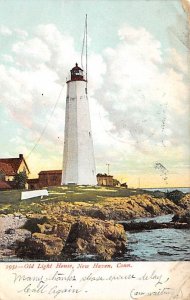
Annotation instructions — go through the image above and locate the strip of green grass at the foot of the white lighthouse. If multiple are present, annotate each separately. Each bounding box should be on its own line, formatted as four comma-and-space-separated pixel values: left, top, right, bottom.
0, 186, 140, 214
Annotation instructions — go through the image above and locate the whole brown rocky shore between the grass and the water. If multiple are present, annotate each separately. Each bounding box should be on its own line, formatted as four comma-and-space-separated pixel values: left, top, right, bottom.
0, 193, 190, 260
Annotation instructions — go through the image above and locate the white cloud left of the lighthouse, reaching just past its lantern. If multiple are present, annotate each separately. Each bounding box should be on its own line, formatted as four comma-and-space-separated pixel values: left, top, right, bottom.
0, 24, 104, 166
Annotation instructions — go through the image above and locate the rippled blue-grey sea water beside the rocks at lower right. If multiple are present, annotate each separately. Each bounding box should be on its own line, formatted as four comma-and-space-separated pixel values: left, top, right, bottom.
123, 215, 190, 261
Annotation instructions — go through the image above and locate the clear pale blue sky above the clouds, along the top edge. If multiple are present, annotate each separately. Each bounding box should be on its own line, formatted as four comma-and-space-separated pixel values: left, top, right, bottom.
0, 0, 184, 55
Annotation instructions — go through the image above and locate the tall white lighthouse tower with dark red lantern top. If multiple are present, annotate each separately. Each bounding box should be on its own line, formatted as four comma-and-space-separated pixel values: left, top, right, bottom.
62, 63, 97, 185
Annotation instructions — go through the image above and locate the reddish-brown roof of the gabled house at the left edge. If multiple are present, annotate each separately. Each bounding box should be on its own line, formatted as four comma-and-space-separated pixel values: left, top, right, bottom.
0, 154, 30, 176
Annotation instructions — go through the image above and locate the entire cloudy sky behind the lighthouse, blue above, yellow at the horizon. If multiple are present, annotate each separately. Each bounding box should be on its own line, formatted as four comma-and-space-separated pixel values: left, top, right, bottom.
0, 0, 190, 187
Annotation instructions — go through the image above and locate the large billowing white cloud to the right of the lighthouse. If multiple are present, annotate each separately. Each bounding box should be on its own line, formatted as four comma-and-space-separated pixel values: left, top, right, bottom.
95, 26, 189, 155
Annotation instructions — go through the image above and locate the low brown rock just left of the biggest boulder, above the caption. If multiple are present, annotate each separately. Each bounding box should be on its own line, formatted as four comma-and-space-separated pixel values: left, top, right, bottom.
16, 233, 63, 259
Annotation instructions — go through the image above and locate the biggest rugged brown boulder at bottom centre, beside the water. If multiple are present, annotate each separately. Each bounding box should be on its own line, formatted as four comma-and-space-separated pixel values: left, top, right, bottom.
63, 218, 126, 260
